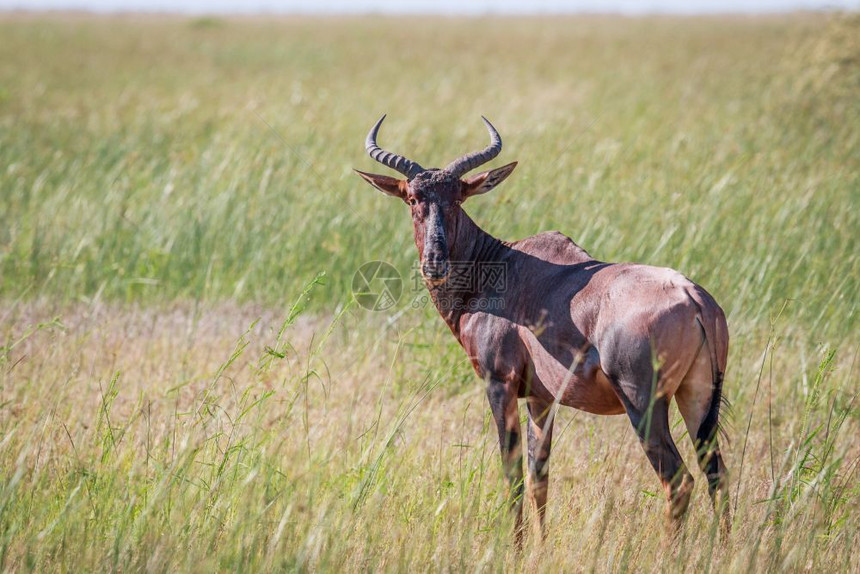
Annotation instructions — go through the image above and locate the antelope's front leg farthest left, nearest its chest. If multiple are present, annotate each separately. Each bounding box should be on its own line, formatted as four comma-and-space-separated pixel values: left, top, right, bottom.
487, 381, 523, 546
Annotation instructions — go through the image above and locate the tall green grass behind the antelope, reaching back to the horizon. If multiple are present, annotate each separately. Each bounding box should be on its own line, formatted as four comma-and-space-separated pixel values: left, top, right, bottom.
0, 16, 860, 342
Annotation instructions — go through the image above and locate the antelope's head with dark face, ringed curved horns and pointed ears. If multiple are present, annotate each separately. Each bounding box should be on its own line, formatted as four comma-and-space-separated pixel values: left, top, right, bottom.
355, 116, 517, 285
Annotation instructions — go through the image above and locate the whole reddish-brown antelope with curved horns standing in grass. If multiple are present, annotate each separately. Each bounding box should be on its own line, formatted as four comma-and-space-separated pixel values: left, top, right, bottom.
355, 115, 730, 544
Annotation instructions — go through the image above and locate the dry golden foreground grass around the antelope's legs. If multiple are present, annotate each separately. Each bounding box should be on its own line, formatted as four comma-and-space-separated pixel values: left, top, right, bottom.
0, 294, 860, 572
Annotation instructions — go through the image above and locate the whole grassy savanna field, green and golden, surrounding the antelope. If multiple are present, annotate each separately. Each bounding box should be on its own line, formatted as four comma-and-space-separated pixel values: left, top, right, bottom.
0, 14, 860, 572
